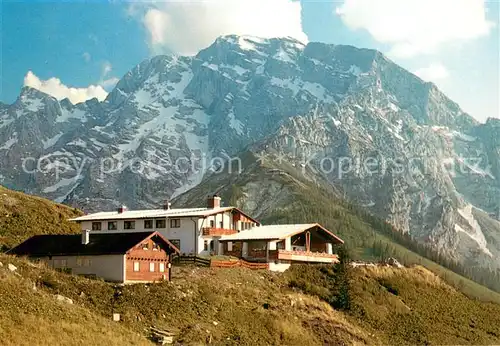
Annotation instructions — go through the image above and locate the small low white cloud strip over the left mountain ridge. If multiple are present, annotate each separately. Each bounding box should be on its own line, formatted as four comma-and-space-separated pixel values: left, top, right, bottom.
24, 71, 108, 104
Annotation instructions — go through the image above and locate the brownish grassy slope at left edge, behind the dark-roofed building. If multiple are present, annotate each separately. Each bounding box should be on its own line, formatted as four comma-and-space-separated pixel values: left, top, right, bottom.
0, 186, 81, 249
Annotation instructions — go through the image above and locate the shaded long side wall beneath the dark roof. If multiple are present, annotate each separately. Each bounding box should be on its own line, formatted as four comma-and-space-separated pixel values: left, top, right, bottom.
40, 255, 125, 282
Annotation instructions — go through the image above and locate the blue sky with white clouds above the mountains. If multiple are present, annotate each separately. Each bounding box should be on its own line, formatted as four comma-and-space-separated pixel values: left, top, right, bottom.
0, 0, 500, 121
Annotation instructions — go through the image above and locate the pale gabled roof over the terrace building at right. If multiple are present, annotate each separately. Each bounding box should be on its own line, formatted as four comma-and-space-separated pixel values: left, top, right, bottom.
219, 223, 344, 244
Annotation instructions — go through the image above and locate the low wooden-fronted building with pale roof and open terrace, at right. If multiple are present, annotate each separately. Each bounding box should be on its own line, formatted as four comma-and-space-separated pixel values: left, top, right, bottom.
219, 223, 344, 271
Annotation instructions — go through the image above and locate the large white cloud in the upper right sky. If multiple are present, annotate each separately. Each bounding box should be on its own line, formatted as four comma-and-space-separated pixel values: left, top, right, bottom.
336, 0, 494, 58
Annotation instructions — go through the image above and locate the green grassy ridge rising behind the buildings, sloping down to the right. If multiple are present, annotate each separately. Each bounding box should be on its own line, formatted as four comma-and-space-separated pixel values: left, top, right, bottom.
174, 153, 500, 303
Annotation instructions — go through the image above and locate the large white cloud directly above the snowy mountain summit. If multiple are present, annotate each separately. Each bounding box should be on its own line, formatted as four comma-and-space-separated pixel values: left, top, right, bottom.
136, 0, 307, 54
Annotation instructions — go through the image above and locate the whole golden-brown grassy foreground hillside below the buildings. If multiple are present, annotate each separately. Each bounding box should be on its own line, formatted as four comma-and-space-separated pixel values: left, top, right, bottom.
0, 255, 500, 345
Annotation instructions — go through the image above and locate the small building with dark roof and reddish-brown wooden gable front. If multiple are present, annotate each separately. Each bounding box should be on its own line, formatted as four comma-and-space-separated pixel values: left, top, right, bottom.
8, 230, 179, 283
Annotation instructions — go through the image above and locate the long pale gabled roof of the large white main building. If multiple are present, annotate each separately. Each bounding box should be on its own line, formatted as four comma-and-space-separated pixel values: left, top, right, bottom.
70, 207, 260, 224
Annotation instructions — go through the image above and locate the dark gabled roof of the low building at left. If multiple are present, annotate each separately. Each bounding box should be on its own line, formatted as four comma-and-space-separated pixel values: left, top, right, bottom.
8, 232, 179, 257
